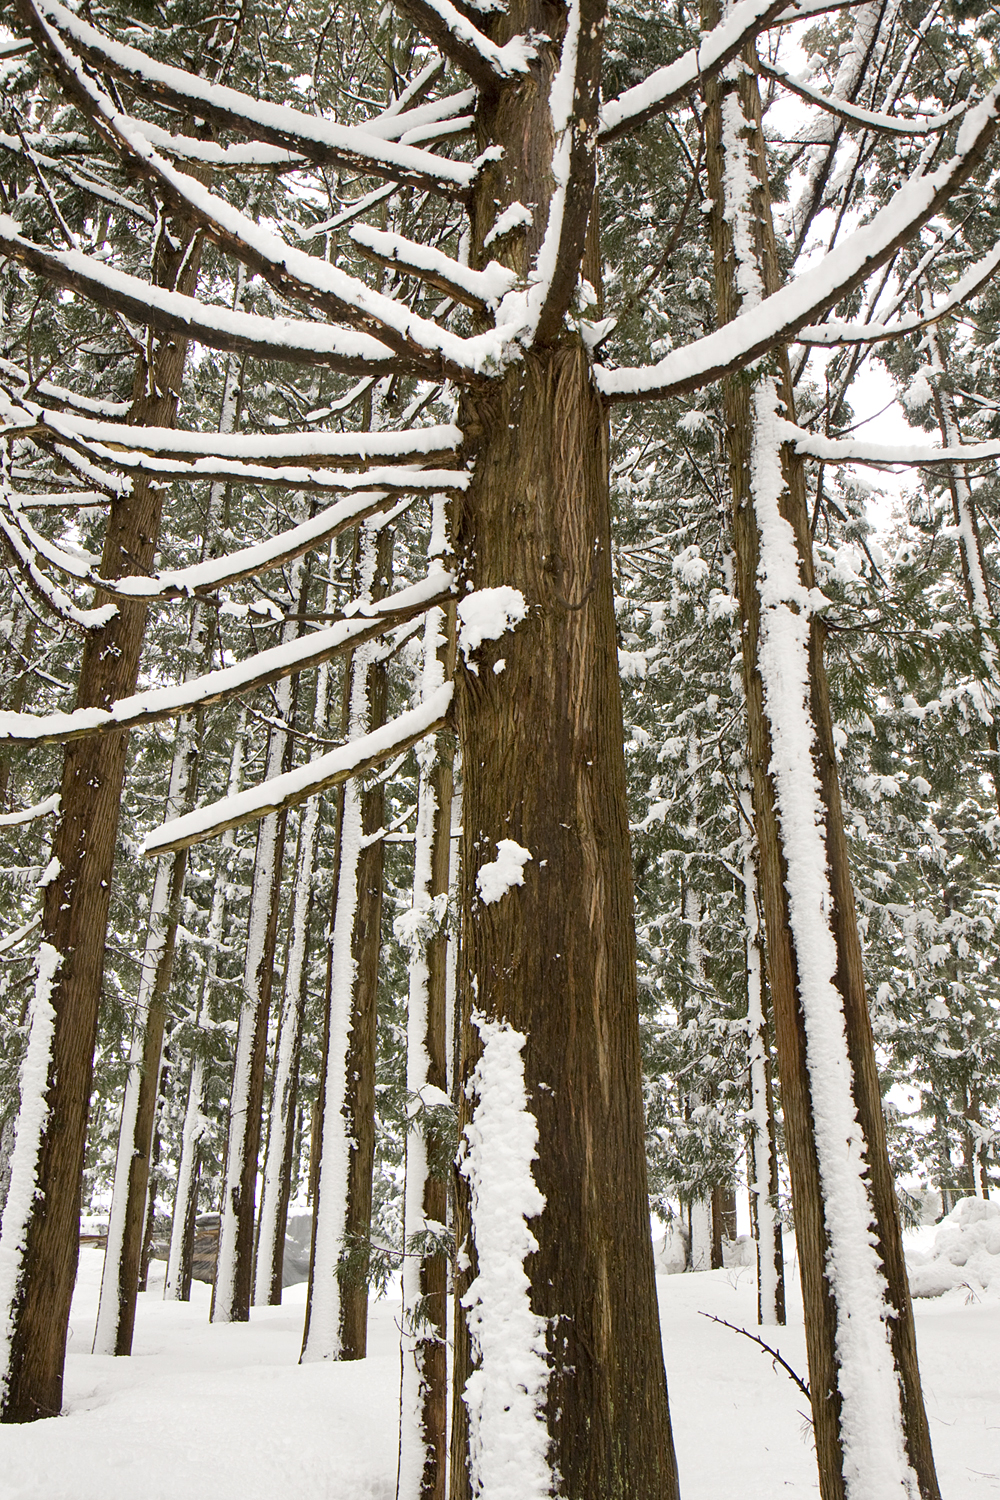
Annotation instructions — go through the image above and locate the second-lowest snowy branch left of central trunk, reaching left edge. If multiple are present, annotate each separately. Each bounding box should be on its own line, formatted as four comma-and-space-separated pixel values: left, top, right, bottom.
0, 573, 454, 744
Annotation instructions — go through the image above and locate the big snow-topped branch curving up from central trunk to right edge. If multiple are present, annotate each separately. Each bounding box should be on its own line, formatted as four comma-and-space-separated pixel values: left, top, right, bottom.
594, 89, 1000, 401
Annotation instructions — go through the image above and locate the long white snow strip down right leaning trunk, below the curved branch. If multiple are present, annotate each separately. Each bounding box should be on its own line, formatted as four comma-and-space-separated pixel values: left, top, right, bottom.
751, 378, 918, 1500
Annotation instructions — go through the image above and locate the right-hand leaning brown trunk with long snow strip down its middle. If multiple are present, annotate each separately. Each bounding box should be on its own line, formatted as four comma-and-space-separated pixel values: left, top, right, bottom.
706, 8, 939, 1500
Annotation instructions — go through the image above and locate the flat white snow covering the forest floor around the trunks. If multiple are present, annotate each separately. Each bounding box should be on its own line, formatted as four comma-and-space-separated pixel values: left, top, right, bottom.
0, 1250, 1000, 1500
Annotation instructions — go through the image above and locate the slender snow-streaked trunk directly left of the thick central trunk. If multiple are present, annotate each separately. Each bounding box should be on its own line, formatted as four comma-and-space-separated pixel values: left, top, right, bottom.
396, 498, 454, 1500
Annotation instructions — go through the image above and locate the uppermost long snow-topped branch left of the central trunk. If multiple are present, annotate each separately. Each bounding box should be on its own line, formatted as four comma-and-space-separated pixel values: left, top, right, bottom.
16, 0, 478, 197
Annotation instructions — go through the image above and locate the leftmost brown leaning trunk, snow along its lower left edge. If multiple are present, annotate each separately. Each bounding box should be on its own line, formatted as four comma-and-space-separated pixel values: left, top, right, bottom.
0, 222, 199, 1422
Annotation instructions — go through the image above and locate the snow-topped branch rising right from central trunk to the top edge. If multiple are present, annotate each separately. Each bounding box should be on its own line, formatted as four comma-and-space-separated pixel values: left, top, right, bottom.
600, 0, 791, 143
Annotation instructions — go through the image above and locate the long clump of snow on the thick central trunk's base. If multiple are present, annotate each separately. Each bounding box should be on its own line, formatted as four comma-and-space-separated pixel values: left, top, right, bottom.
460, 1020, 552, 1500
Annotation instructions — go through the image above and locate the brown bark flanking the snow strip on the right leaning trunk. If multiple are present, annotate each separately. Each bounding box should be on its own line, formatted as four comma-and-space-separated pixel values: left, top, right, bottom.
706, 23, 939, 1500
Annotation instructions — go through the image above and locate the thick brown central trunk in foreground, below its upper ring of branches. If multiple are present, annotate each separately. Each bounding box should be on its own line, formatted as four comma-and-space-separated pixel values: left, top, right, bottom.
451, 337, 676, 1500
